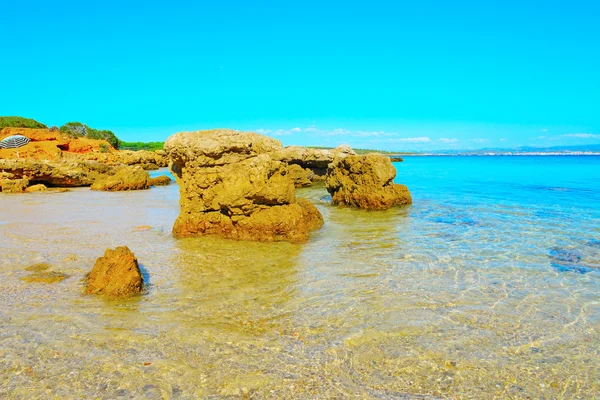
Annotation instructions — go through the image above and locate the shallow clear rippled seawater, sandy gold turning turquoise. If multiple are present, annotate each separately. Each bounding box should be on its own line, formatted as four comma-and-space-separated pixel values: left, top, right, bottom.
0, 157, 600, 399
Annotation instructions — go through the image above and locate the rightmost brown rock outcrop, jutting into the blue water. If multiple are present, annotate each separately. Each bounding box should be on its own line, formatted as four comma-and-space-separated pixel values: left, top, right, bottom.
325, 154, 412, 210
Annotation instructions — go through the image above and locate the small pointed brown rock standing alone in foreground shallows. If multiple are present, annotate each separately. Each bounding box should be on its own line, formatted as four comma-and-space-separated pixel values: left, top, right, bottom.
87, 246, 144, 297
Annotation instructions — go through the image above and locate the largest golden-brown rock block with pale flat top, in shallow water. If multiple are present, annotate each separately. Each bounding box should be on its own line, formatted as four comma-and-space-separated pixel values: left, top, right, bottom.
165, 129, 323, 242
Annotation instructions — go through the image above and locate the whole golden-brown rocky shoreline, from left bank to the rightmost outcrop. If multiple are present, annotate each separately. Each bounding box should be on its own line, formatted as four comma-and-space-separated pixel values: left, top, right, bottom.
0, 128, 412, 255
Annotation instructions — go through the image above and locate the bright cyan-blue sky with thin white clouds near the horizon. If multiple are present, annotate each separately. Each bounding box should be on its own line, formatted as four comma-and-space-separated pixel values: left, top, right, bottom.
0, 0, 600, 150
